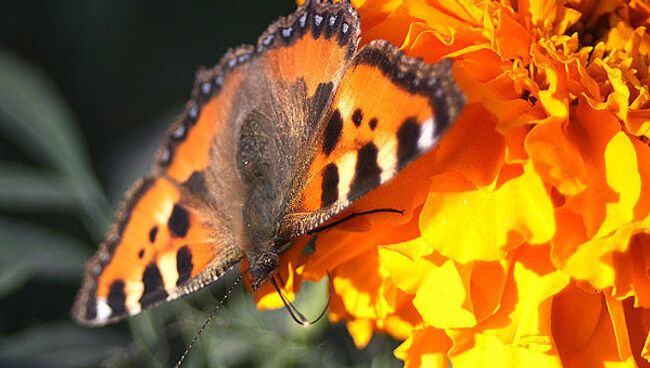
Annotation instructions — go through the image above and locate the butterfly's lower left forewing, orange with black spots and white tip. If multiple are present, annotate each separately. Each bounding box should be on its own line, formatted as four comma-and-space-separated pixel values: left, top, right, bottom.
73, 177, 242, 325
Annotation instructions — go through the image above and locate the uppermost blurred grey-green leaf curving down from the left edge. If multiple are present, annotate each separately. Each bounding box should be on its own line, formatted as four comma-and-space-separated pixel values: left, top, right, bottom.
0, 50, 110, 235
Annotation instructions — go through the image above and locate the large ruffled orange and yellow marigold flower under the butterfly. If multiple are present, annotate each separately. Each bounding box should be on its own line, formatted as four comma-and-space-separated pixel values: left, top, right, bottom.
257, 0, 650, 367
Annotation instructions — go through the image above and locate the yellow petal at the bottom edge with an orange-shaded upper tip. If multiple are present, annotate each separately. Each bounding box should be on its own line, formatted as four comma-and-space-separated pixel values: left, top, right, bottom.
447, 246, 569, 367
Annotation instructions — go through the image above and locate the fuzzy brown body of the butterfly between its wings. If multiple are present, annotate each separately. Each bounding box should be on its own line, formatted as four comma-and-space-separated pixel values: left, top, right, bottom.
237, 105, 306, 289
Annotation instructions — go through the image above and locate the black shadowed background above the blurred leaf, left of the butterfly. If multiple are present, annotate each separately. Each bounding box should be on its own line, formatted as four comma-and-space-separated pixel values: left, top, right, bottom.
0, 0, 295, 181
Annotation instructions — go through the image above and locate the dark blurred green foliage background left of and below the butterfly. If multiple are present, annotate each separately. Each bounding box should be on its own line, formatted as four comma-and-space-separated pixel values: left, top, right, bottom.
0, 0, 399, 367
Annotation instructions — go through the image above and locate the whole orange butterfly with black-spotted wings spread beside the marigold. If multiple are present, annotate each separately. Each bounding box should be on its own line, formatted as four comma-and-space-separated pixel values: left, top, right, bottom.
72, 0, 465, 326
